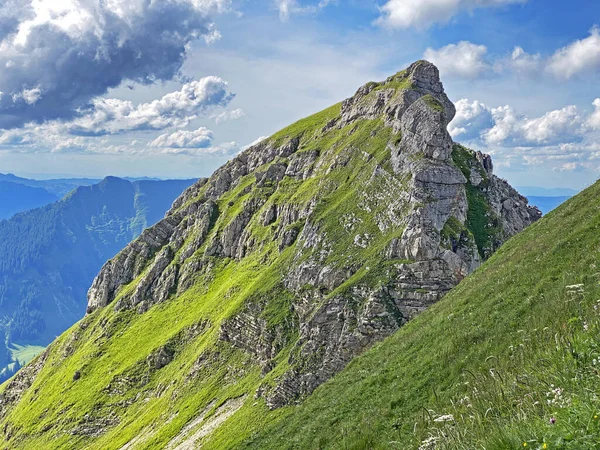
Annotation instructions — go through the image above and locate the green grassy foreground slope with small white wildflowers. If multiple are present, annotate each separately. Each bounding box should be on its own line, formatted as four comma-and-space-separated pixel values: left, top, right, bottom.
241, 178, 600, 450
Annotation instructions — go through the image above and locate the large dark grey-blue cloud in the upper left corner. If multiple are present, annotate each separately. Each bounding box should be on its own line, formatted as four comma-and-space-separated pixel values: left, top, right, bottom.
0, 0, 230, 129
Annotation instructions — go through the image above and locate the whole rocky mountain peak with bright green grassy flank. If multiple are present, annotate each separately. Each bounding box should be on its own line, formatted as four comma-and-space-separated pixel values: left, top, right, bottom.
0, 61, 540, 449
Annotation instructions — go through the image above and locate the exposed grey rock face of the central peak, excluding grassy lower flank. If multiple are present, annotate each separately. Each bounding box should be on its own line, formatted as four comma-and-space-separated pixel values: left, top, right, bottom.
83, 61, 541, 408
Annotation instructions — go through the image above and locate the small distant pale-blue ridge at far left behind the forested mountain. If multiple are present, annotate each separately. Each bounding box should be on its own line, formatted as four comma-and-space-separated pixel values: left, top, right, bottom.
0, 181, 58, 219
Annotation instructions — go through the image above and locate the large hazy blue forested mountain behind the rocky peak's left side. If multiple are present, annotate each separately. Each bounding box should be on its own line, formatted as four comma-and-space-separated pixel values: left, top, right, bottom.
0, 177, 192, 382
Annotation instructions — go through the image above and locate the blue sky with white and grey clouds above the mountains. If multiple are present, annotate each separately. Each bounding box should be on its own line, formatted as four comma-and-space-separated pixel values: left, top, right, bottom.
0, 0, 600, 189
